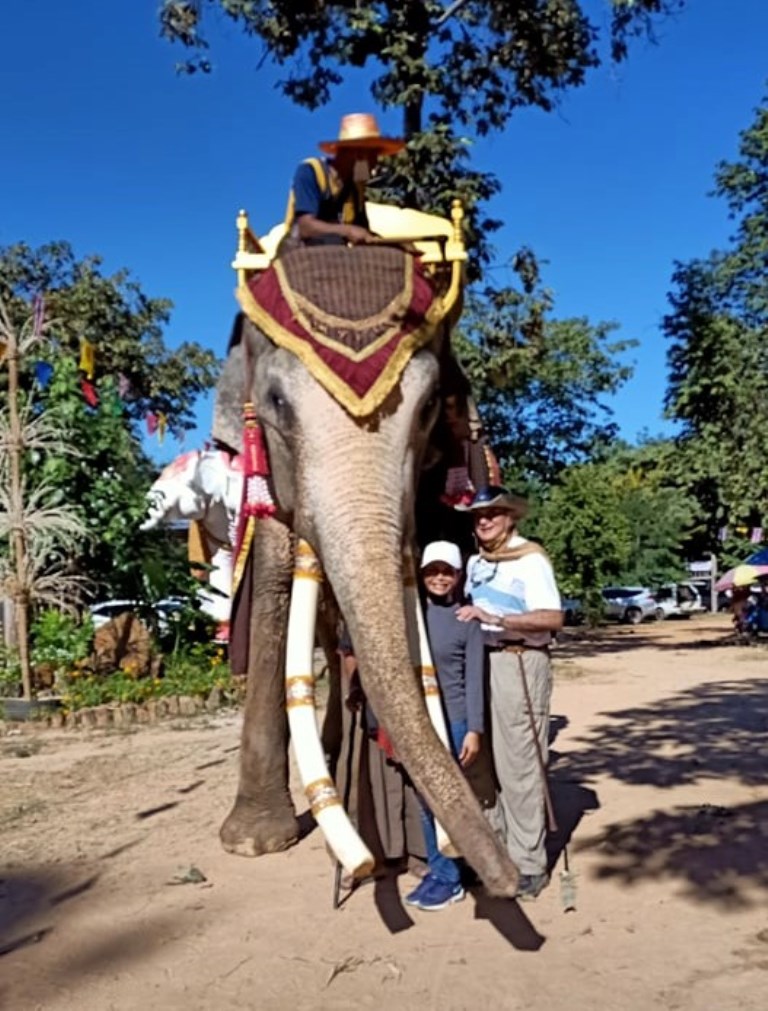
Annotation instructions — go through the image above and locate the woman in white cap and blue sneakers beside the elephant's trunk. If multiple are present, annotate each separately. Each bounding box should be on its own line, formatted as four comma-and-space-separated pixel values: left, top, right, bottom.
405, 541, 483, 911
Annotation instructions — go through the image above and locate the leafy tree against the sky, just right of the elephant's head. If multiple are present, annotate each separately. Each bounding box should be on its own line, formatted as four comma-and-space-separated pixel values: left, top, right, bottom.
454, 250, 637, 489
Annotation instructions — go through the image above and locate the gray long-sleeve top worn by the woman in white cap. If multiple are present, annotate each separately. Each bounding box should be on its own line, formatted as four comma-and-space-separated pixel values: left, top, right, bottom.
426, 598, 484, 734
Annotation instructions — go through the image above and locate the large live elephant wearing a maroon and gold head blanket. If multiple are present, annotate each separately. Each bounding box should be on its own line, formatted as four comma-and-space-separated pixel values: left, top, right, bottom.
213, 238, 517, 897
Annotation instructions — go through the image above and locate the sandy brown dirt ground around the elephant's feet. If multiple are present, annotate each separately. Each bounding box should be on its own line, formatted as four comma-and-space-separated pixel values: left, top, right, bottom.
0, 617, 768, 1011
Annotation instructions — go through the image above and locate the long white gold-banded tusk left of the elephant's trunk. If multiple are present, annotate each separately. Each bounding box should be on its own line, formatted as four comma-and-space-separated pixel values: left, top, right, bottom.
285, 540, 375, 878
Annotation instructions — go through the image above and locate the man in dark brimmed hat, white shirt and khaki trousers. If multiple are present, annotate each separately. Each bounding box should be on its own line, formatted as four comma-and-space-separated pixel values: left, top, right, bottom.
457, 485, 563, 899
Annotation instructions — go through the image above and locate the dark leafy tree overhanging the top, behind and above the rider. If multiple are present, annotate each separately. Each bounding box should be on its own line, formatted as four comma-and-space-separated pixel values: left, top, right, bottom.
160, 0, 684, 270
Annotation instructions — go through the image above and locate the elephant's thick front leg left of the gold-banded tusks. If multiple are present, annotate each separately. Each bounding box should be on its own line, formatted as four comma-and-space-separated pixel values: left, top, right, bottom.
220, 520, 298, 856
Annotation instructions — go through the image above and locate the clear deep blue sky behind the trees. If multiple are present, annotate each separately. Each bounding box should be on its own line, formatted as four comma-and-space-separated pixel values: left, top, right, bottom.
0, 0, 768, 458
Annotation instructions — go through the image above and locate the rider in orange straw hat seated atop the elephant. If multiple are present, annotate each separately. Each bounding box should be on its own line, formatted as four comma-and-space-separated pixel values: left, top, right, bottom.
280, 112, 405, 252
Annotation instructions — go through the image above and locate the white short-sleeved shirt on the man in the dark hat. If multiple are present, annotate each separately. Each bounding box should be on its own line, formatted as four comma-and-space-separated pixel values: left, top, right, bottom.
464, 534, 561, 646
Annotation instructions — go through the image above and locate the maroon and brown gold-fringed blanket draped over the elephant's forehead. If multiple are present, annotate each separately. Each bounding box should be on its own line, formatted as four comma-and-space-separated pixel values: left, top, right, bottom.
237, 246, 442, 418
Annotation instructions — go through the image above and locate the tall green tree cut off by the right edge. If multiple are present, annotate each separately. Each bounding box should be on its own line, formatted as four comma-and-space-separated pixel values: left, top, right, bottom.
664, 92, 768, 551
